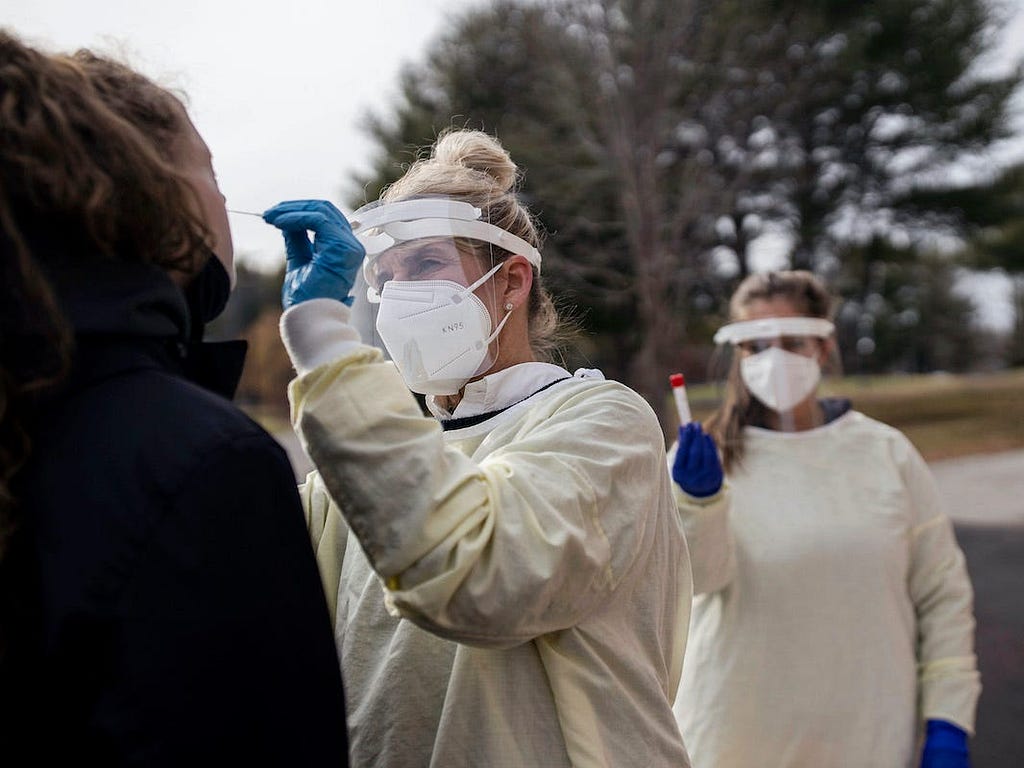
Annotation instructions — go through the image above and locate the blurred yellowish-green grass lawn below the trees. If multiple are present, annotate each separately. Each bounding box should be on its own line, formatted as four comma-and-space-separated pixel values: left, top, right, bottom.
687, 369, 1024, 461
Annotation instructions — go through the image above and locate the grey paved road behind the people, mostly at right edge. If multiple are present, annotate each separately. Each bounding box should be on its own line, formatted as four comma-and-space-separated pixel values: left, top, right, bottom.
279, 433, 1024, 768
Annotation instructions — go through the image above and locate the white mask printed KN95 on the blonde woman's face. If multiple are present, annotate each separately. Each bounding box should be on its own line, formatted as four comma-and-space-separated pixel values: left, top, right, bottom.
377, 263, 511, 395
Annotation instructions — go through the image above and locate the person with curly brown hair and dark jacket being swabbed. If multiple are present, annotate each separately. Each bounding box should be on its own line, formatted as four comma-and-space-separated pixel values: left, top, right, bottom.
0, 30, 347, 768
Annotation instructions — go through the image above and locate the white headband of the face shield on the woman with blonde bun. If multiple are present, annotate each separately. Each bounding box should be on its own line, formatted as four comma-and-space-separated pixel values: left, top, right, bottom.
351, 198, 541, 302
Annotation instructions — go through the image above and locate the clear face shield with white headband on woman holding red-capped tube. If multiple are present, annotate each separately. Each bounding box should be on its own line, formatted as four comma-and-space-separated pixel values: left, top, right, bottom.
715, 317, 836, 429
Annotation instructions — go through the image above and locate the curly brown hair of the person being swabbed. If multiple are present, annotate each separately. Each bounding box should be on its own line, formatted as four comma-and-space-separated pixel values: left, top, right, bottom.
0, 30, 210, 557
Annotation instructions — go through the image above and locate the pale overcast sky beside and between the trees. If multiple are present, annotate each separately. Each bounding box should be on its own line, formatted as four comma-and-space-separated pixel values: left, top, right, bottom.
0, 0, 1024, 323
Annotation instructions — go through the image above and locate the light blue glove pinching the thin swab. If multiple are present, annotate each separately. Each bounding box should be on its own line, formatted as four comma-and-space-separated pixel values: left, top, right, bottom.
263, 200, 366, 309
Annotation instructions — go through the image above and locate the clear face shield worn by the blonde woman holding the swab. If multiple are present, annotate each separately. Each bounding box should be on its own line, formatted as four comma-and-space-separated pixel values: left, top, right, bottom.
352, 197, 541, 395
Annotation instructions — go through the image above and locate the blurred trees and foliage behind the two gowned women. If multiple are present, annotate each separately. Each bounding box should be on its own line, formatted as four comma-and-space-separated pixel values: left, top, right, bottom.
214, 0, 1024, 434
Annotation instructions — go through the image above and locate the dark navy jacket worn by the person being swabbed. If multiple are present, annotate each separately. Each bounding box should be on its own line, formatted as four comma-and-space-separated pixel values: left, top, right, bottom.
0, 264, 347, 766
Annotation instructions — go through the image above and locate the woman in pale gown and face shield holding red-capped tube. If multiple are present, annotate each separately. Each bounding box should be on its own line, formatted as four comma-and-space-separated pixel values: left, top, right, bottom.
670, 271, 980, 768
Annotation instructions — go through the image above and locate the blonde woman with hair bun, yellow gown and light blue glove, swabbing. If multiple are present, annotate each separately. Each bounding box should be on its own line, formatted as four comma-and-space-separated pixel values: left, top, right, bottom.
264, 131, 691, 766
